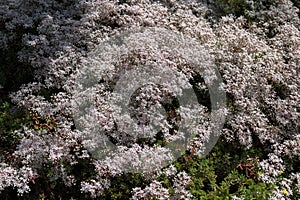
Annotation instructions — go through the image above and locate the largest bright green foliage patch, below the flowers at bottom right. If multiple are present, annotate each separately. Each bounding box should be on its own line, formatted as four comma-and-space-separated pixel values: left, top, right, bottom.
159, 139, 274, 200
